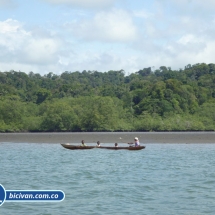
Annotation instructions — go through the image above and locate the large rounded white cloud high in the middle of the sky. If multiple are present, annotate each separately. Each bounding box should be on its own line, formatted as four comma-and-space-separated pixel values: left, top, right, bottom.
66, 9, 137, 42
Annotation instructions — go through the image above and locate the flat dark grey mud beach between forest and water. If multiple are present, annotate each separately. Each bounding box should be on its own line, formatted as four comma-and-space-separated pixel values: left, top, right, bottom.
0, 132, 215, 143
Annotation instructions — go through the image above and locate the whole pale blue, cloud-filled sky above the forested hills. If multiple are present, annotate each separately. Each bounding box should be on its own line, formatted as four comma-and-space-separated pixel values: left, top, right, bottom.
0, 0, 215, 75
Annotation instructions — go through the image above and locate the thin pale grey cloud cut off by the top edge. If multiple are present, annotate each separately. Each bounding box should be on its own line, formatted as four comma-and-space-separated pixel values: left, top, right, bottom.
43, 0, 116, 8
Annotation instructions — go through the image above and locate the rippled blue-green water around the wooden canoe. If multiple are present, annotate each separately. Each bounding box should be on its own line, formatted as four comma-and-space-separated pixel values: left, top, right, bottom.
0, 143, 215, 215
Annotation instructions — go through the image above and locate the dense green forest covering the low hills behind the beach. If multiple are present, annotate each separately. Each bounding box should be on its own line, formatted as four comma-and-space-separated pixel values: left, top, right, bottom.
0, 63, 215, 132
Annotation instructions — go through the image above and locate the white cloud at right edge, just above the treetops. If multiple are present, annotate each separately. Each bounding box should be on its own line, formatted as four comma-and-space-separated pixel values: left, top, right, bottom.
138, 31, 215, 69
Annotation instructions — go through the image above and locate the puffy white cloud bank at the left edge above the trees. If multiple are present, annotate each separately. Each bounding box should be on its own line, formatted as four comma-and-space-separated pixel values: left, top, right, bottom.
0, 19, 61, 66
